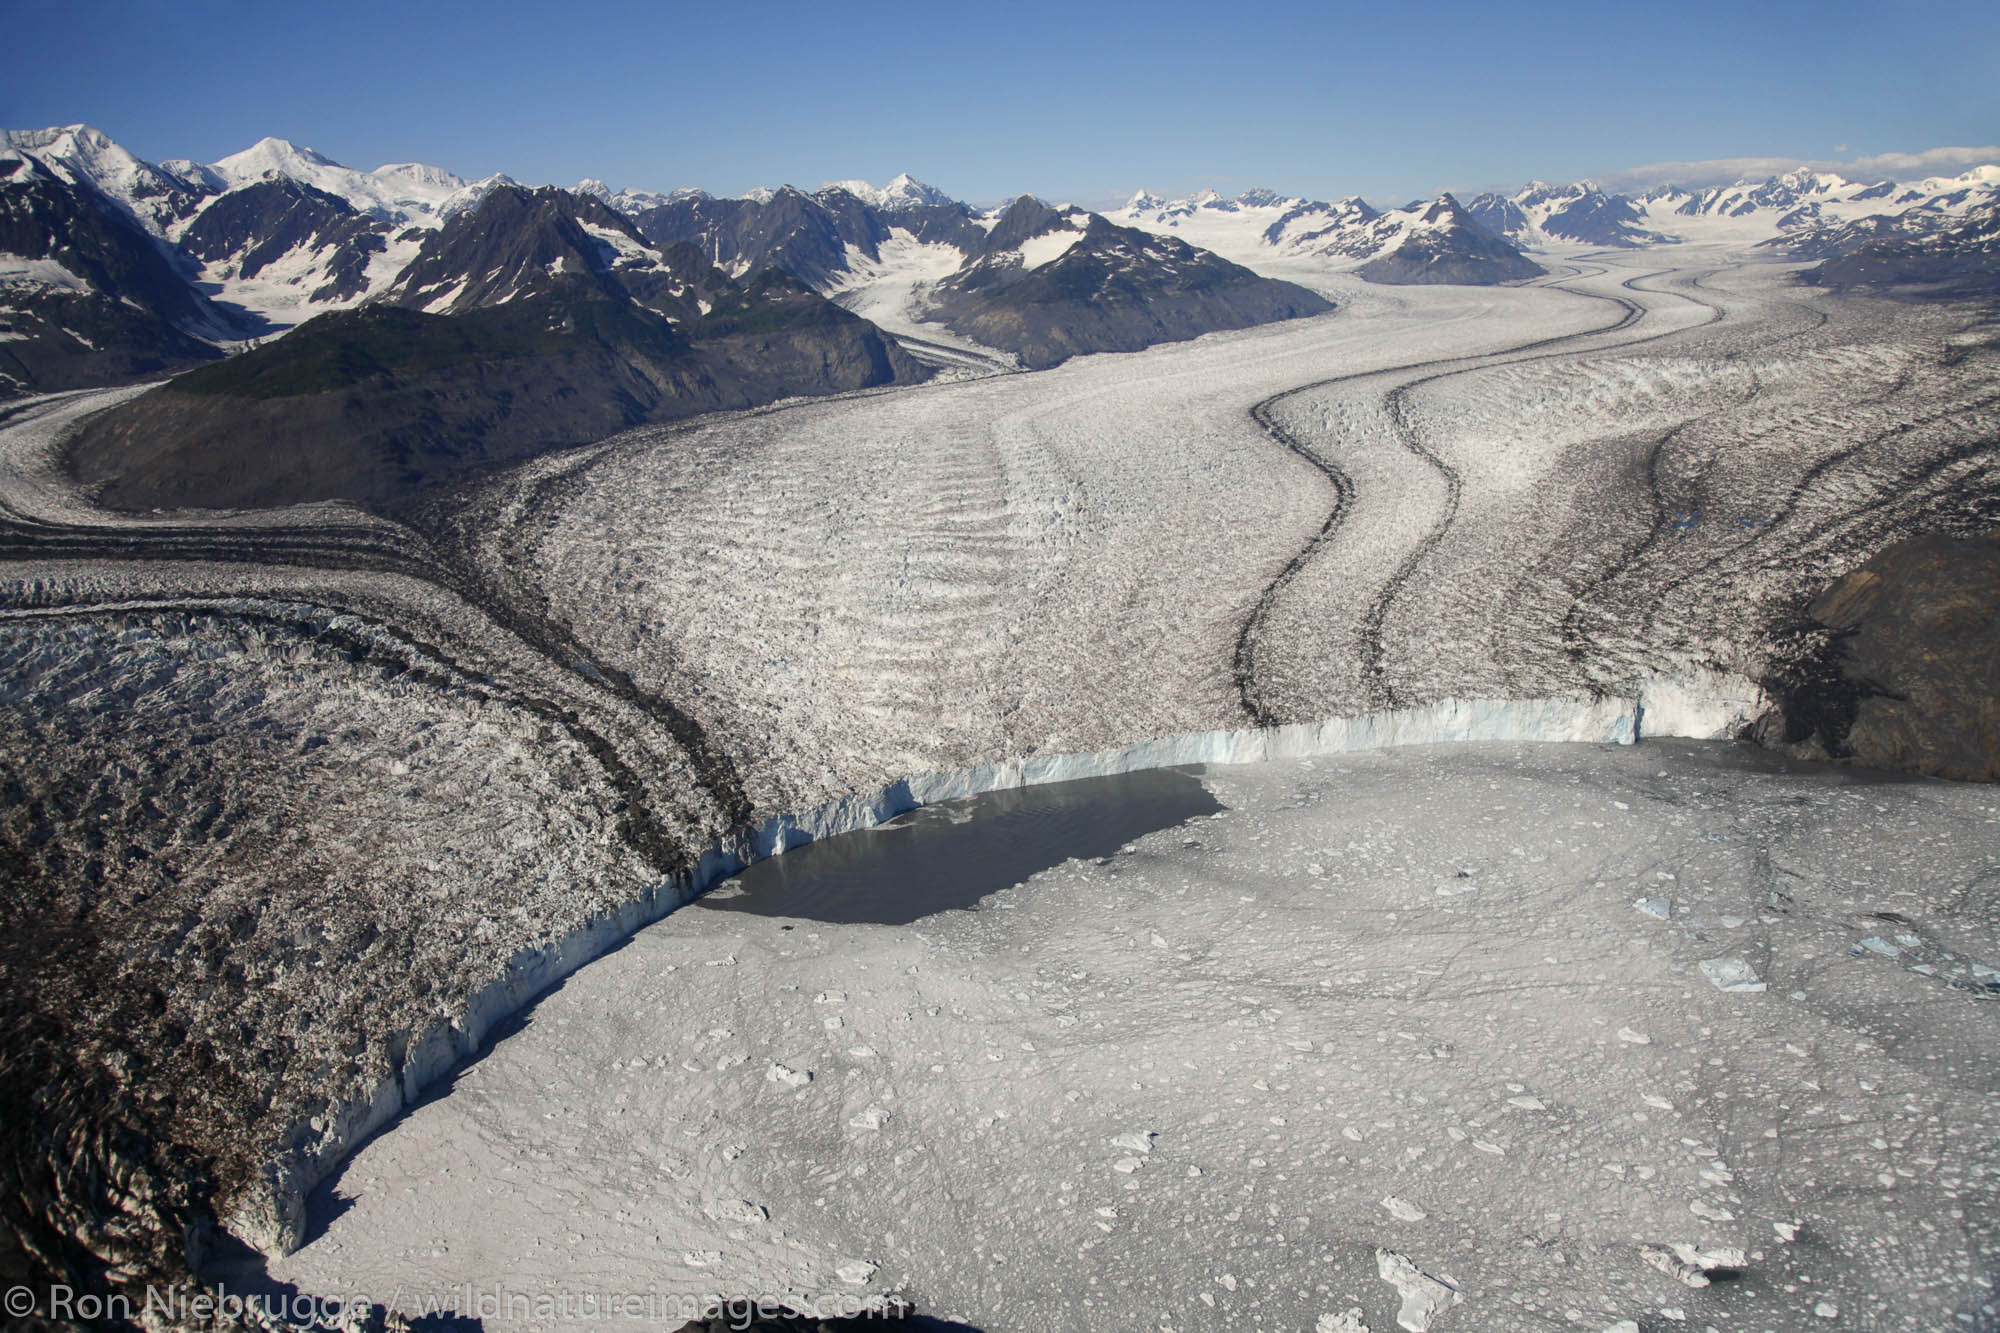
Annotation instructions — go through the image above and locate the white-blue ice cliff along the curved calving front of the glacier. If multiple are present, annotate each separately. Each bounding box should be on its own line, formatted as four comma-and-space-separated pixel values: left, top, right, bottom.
222, 673, 1762, 1257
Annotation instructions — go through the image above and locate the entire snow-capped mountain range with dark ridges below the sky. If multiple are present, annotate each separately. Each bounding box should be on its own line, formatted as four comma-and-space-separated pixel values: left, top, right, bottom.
0, 126, 2000, 504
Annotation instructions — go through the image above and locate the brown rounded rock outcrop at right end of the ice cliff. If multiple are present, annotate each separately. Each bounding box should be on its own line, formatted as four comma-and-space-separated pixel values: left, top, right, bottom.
1754, 532, 2000, 783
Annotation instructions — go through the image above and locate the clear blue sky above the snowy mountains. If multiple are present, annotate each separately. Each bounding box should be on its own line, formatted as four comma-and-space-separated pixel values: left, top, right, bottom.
0, 0, 2000, 202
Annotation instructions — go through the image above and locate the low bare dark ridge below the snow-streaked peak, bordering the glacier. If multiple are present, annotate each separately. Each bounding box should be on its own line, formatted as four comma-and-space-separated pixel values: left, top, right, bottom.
70, 276, 924, 508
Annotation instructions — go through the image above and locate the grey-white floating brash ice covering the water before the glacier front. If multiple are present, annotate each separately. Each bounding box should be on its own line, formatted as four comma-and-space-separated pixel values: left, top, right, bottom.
274, 743, 2000, 1333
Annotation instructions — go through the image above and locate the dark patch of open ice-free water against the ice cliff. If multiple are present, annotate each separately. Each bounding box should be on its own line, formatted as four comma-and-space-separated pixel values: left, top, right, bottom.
700, 765, 1222, 925
